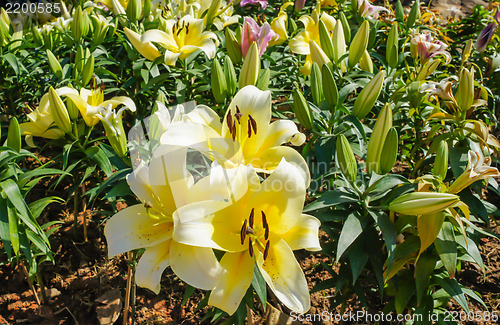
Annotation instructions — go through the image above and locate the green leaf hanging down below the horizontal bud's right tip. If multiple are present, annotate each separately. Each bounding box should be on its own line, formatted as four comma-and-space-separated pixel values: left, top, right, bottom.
434, 222, 457, 278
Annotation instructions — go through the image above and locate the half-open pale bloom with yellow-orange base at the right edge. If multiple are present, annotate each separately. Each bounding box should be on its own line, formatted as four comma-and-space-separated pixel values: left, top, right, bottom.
448, 150, 500, 193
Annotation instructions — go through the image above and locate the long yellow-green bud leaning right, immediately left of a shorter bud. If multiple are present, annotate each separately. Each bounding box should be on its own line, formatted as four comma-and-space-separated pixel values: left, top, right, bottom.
366, 104, 392, 174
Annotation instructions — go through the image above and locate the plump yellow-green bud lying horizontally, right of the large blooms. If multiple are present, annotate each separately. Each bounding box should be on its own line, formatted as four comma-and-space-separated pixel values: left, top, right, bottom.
389, 192, 460, 215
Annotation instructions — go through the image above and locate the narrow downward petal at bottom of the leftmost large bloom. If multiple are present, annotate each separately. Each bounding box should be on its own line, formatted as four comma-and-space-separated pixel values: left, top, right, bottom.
135, 239, 173, 294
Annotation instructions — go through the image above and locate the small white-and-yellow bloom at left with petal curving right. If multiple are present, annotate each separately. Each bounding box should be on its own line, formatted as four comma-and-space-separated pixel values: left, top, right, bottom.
63, 84, 136, 126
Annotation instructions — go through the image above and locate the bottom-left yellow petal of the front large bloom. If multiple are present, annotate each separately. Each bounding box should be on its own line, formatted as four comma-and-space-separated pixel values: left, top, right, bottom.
208, 251, 255, 315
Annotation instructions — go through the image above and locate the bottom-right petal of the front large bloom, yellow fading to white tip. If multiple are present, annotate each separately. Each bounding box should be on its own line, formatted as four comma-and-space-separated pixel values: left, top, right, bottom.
257, 240, 311, 314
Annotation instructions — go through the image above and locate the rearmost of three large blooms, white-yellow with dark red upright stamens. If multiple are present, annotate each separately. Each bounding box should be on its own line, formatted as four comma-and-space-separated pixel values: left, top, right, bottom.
161, 86, 310, 184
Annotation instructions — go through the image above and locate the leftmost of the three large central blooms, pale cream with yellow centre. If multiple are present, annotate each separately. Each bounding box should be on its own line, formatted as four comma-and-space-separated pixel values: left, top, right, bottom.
104, 146, 220, 293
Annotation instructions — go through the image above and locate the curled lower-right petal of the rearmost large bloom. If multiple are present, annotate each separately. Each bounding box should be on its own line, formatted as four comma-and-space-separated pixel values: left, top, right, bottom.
254, 146, 311, 188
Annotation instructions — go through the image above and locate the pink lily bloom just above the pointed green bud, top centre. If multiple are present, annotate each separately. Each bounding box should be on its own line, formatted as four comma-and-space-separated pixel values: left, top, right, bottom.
241, 17, 279, 57
